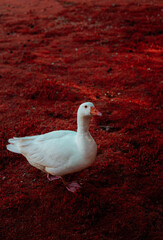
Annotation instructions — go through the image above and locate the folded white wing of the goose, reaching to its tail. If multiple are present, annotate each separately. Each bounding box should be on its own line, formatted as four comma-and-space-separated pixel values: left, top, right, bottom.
8, 131, 76, 168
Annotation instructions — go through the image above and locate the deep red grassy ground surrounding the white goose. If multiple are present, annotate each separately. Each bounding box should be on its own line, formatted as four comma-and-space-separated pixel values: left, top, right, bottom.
0, 0, 163, 240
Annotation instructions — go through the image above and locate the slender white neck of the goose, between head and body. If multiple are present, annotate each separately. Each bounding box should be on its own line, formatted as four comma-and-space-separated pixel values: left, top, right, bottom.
77, 115, 90, 134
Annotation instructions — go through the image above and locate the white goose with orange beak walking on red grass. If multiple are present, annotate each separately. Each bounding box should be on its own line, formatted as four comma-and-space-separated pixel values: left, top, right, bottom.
7, 102, 102, 192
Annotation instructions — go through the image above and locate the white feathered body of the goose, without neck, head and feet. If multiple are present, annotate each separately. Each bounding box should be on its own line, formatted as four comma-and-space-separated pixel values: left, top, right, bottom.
8, 131, 97, 176
